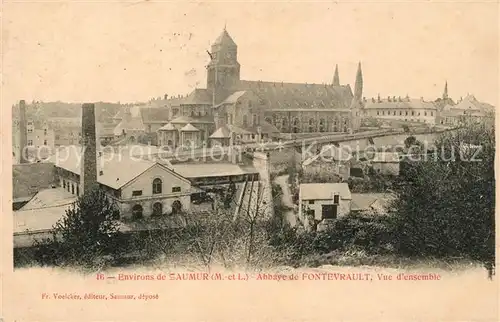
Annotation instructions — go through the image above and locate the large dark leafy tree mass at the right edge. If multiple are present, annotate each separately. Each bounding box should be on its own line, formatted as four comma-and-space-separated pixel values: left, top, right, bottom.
394, 124, 495, 278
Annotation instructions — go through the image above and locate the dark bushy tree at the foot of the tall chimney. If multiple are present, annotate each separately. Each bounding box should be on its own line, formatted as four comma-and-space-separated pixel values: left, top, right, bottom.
38, 188, 120, 268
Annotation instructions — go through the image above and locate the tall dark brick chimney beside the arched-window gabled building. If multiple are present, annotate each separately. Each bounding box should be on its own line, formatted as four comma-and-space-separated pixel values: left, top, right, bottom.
80, 103, 97, 194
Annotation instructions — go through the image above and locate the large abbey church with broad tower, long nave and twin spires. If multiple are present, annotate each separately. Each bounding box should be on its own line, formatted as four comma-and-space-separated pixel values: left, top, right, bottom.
152, 28, 363, 146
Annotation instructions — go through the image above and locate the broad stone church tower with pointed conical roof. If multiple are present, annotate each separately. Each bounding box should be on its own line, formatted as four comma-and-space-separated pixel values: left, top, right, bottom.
207, 27, 240, 104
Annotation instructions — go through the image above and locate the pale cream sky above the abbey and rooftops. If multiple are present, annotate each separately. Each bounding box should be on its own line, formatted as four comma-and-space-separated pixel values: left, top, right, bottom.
2, 0, 499, 106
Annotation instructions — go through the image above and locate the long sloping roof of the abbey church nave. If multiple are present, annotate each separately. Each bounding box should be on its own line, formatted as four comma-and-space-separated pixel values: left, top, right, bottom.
238, 80, 353, 109
